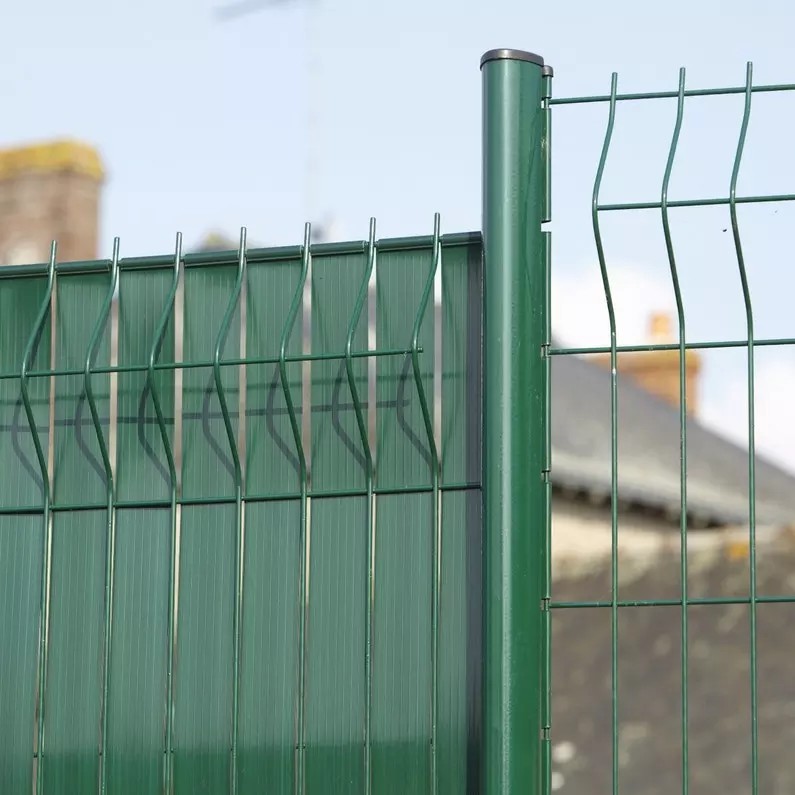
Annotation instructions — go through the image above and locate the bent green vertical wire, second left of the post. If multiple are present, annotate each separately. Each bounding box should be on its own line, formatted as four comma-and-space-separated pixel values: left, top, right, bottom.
345, 218, 375, 795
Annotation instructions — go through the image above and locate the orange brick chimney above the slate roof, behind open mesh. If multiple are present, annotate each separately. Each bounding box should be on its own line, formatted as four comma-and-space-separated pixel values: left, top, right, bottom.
598, 312, 701, 415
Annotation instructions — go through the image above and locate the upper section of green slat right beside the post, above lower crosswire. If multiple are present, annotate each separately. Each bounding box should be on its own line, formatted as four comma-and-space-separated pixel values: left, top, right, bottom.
441, 241, 483, 485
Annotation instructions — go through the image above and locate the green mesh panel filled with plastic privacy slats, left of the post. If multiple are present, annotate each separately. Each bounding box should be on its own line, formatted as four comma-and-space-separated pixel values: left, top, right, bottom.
0, 222, 482, 795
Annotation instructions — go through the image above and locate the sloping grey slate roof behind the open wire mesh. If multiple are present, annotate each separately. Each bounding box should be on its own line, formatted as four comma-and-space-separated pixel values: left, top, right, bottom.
552, 355, 795, 525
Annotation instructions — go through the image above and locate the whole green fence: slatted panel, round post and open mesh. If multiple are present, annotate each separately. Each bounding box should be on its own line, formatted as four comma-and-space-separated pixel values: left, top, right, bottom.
0, 50, 795, 795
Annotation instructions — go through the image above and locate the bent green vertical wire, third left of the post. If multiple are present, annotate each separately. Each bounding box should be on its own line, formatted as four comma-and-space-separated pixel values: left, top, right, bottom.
279, 223, 312, 795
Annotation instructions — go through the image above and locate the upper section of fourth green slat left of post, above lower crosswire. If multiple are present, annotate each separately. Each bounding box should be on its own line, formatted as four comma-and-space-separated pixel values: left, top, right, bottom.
246, 258, 302, 495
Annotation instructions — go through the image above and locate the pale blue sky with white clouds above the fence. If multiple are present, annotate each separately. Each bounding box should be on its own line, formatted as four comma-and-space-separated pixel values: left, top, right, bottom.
0, 0, 795, 467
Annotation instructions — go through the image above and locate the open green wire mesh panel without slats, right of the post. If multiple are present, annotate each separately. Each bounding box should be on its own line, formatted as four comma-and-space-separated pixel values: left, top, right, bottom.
545, 63, 795, 793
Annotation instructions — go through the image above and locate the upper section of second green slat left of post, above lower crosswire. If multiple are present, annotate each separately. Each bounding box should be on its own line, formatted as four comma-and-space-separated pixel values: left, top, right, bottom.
376, 246, 434, 488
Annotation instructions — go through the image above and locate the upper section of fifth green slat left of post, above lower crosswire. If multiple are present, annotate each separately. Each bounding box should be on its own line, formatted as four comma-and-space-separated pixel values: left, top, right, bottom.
182, 266, 240, 499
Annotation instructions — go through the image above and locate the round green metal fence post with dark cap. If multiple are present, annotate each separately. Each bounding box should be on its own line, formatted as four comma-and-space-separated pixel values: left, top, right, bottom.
481, 50, 546, 795
